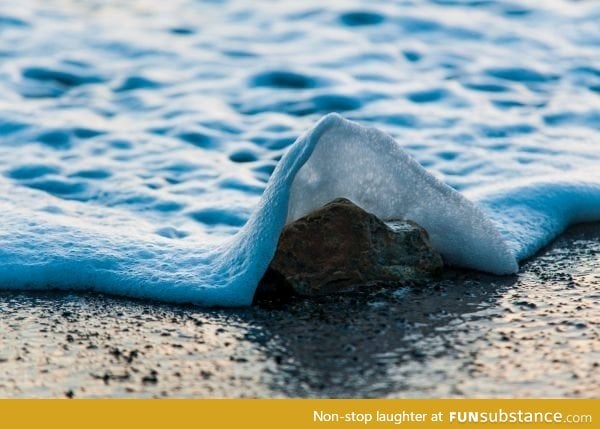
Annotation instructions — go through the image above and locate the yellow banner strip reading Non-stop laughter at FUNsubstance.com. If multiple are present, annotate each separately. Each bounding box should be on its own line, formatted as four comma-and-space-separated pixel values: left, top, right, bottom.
0, 399, 600, 429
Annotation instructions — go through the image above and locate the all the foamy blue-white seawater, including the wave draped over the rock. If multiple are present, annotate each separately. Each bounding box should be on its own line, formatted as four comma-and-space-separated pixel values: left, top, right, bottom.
0, 0, 600, 305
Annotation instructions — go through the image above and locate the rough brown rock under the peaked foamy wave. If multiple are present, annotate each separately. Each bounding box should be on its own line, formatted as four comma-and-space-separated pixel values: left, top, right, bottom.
257, 198, 443, 297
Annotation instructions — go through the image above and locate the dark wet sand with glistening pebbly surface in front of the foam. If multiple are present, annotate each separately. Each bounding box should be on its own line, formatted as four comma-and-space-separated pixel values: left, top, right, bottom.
0, 224, 600, 397
